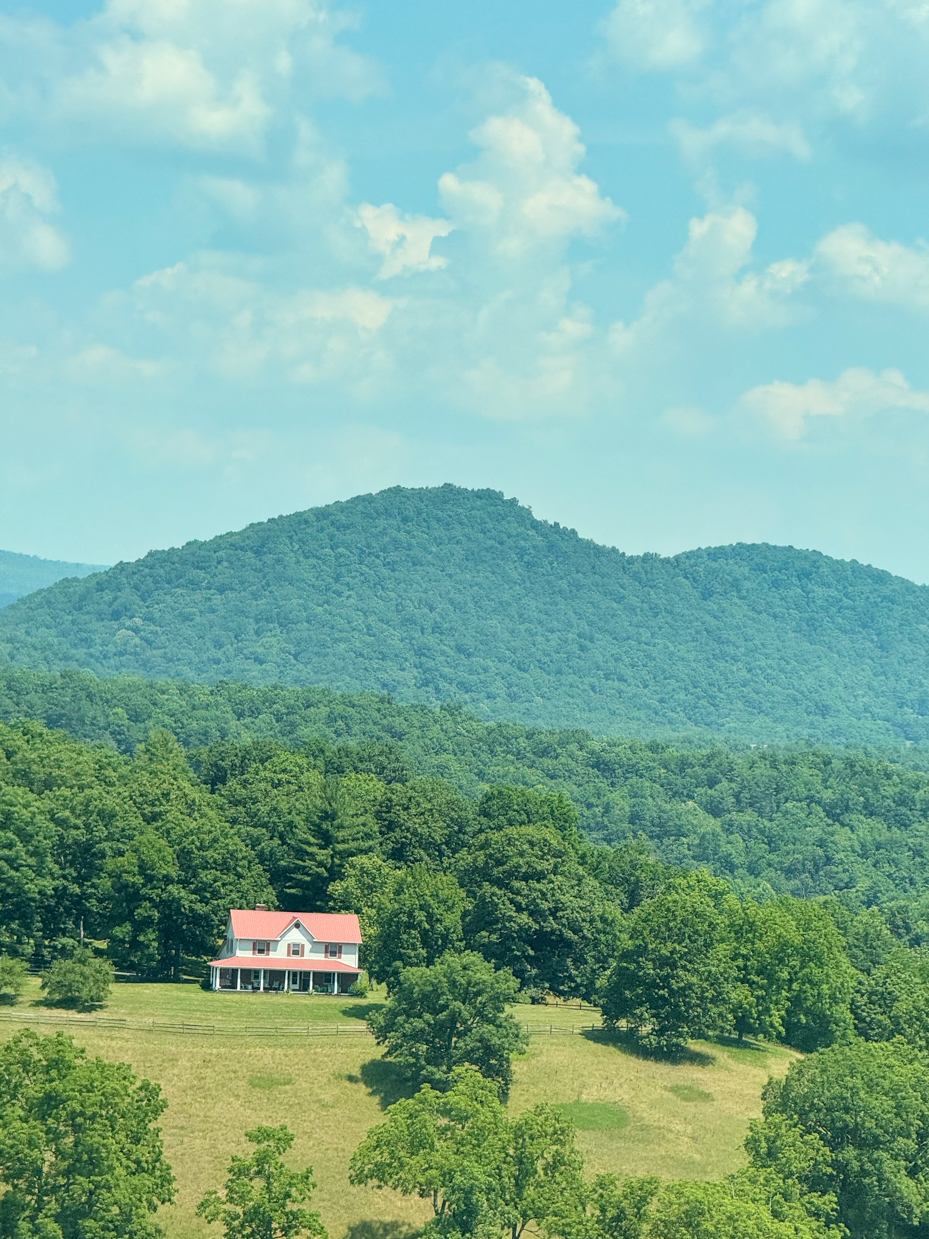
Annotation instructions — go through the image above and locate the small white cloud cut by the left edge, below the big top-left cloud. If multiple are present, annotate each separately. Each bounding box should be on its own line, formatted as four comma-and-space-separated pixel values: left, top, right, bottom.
0, 155, 71, 271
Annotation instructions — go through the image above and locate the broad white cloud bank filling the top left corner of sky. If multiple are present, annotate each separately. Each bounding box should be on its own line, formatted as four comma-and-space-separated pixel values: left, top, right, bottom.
0, 0, 383, 154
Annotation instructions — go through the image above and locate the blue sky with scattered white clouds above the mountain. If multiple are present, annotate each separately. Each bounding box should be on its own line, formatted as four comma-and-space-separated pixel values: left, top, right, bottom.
0, 0, 929, 582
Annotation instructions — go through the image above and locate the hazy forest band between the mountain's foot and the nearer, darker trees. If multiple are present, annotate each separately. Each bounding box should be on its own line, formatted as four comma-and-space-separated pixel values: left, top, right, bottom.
0, 670, 929, 906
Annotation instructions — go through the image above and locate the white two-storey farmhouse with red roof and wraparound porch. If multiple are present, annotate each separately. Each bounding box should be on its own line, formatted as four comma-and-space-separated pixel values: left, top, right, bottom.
209, 903, 362, 994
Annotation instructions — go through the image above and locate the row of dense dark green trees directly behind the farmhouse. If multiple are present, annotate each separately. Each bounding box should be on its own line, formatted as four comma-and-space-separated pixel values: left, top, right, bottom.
0, 722, 929, 1070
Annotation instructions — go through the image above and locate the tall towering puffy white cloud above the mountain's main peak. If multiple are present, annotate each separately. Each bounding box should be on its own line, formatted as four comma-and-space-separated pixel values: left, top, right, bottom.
438, 78, 624, 256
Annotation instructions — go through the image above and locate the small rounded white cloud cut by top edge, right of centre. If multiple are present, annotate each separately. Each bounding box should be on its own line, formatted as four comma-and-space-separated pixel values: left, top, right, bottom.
603, 0, 709, 71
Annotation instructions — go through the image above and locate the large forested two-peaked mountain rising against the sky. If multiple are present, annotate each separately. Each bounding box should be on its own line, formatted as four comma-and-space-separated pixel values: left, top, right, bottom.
0, 486, 929, 743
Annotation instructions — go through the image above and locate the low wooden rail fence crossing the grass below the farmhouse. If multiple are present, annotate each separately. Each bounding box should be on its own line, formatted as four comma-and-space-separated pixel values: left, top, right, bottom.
0, 1011, 602, 1040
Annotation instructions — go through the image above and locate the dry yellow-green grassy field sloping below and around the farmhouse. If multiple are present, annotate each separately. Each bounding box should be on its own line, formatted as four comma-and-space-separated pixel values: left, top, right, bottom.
0, 985, 792, 1239
